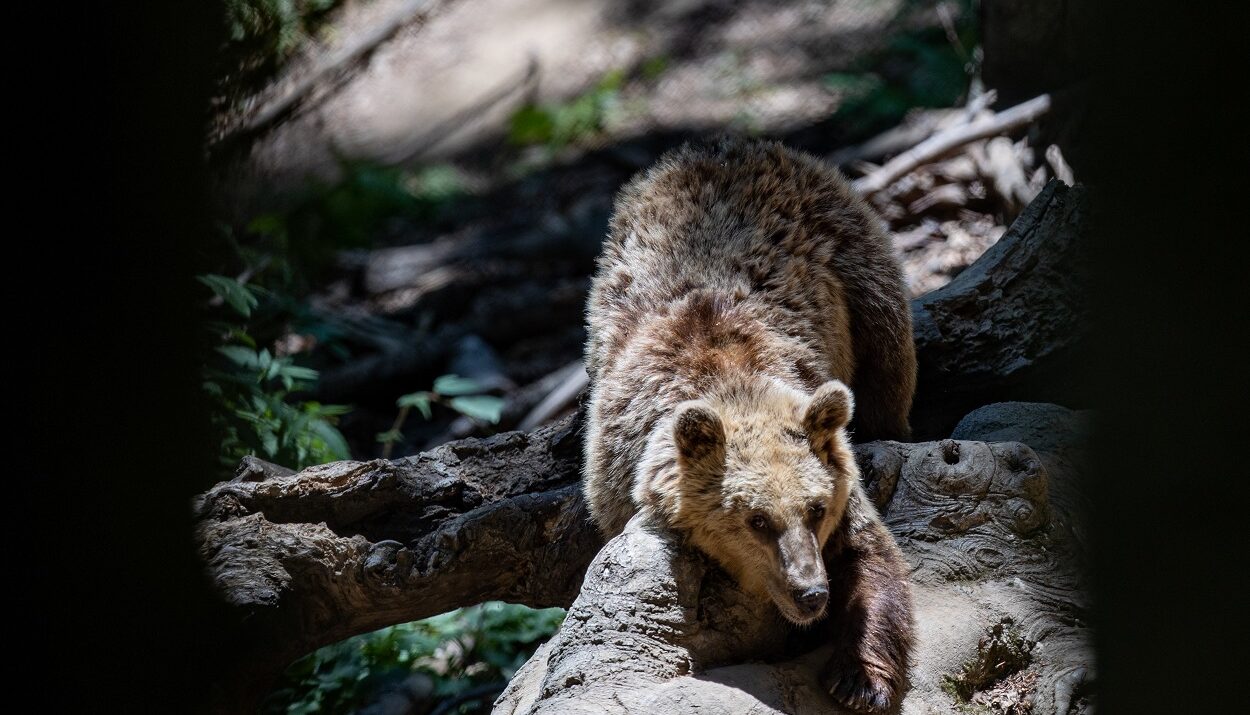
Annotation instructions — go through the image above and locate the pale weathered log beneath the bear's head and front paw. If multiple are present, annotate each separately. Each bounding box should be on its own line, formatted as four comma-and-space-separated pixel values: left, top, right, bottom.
495, 404, 1094, 715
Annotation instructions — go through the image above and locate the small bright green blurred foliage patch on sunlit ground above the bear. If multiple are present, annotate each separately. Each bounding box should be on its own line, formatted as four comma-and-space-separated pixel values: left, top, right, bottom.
509, 66, 625, 151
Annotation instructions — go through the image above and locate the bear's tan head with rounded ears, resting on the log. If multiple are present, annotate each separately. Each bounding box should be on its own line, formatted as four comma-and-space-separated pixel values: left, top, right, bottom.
635, 380, 859, 625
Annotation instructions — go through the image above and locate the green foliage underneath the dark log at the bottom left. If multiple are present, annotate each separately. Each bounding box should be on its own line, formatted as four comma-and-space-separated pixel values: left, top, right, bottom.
265, 601, 564, 714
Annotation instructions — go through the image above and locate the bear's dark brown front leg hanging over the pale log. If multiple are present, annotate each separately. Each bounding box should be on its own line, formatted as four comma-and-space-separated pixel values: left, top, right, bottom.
823, 510, 913, 713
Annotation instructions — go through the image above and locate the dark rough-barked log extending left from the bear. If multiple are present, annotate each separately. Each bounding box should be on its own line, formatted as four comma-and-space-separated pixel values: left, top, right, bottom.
194, 418, 603, 711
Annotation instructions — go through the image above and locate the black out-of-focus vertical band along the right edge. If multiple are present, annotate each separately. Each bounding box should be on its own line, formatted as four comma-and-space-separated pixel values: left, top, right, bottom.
1085, 3, 1250, 713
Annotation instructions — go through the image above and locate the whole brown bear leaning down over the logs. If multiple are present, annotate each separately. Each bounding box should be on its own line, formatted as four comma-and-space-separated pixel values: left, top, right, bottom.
584, 140, 916, 711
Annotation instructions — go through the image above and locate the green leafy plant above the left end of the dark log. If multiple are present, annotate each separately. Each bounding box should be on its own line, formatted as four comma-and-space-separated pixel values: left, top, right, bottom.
199, 275, 351, 470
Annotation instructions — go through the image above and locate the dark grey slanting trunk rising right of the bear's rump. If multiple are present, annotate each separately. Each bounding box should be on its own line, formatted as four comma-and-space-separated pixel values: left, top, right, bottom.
911, 180, 1089, 439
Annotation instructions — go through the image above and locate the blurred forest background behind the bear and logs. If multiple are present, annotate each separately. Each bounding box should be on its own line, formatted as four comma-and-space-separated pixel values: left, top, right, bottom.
187, 0, 1093, 715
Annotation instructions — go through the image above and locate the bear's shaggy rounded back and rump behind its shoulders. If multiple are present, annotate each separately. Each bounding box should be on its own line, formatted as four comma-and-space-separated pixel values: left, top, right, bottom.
586, 140, 893, 389
